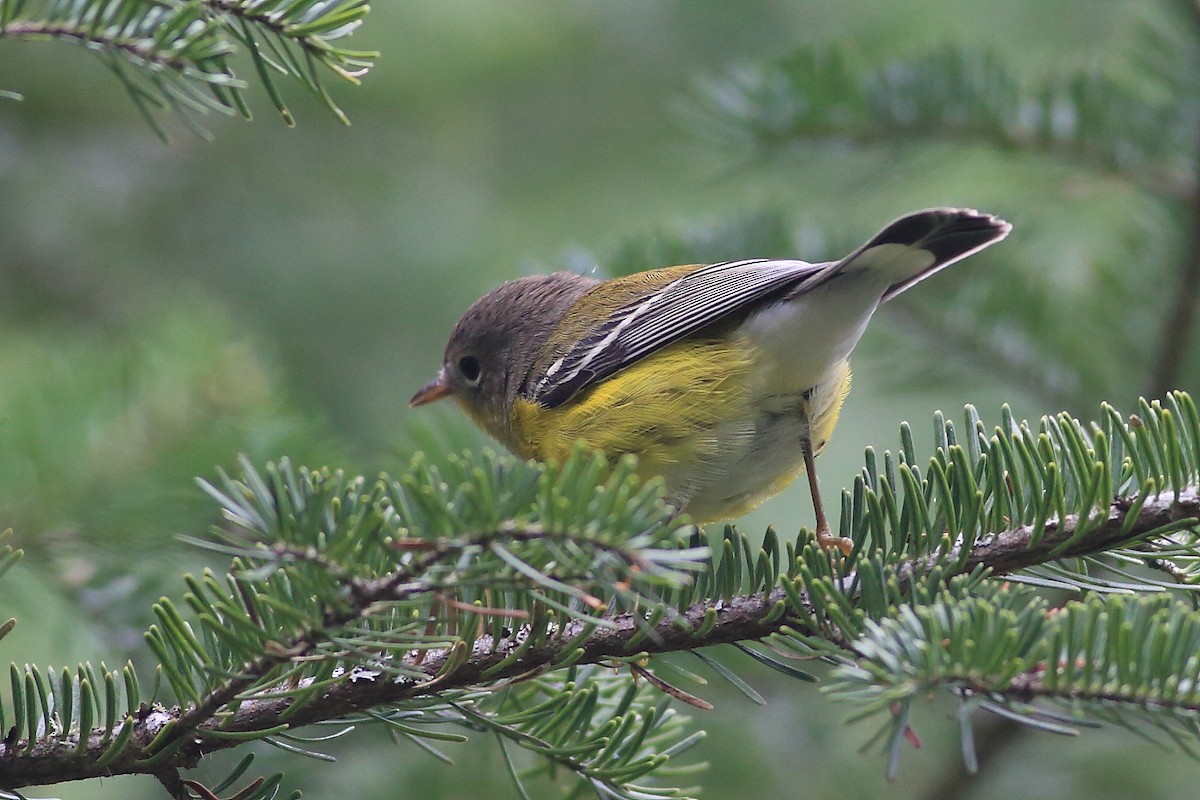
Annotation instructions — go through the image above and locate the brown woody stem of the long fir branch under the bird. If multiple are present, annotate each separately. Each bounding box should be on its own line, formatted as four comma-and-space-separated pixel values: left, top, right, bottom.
0, 487, 1200, 789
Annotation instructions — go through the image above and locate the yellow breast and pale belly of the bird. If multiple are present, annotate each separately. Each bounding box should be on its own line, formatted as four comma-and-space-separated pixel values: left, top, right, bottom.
509, 335, 850, 522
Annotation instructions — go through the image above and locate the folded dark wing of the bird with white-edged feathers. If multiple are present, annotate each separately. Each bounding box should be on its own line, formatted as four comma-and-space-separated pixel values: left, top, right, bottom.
529, 259, 828, 408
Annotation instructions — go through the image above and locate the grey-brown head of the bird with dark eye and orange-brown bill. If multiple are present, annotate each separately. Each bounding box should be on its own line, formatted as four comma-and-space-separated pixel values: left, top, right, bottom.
409, 272, 598, 445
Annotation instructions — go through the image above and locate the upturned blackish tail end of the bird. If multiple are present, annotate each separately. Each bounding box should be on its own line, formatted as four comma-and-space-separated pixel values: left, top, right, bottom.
829, 209, 1013, 302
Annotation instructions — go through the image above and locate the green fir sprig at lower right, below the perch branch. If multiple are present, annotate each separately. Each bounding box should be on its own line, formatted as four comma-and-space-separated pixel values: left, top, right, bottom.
830, 588, 1200, 767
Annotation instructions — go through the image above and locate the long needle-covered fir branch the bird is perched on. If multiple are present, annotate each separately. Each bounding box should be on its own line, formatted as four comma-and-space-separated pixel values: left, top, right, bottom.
0, 395, 1200, 796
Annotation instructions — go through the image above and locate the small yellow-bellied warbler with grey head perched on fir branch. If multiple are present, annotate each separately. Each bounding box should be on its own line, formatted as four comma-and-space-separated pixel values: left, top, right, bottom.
410, 209, 1012, 553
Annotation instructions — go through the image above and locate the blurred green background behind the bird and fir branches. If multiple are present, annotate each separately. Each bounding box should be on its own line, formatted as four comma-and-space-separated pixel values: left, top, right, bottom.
0, 0, 1200, 800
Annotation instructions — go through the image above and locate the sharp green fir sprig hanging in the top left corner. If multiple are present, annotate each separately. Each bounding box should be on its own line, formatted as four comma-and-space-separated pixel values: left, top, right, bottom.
0, 0, 377, 140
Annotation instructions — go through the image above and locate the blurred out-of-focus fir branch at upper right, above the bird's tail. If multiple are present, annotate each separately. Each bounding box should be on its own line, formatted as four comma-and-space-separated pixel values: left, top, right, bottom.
691, 46, 1195, 197
